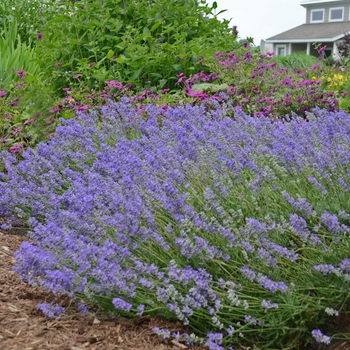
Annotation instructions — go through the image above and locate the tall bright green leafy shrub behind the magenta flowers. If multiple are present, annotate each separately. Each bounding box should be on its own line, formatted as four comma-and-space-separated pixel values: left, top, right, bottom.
37, 0, 236, 90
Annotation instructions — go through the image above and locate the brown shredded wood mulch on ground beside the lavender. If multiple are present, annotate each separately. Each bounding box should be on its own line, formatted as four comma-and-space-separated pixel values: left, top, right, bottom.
0, 228, 204, 350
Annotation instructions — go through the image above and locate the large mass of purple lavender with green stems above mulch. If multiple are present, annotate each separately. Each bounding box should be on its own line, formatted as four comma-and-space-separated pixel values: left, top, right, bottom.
0, 99, 350, 349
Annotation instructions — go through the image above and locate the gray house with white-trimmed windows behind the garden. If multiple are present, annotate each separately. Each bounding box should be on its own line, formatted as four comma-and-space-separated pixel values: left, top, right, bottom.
264, 0, 350, 58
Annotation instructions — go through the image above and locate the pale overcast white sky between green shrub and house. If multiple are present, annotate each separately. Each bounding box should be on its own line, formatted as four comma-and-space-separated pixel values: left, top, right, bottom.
215, 0, 306, 46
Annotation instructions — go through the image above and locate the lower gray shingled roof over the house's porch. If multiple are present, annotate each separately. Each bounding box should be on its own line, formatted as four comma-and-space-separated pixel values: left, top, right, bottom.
265, 21, 350, 42
